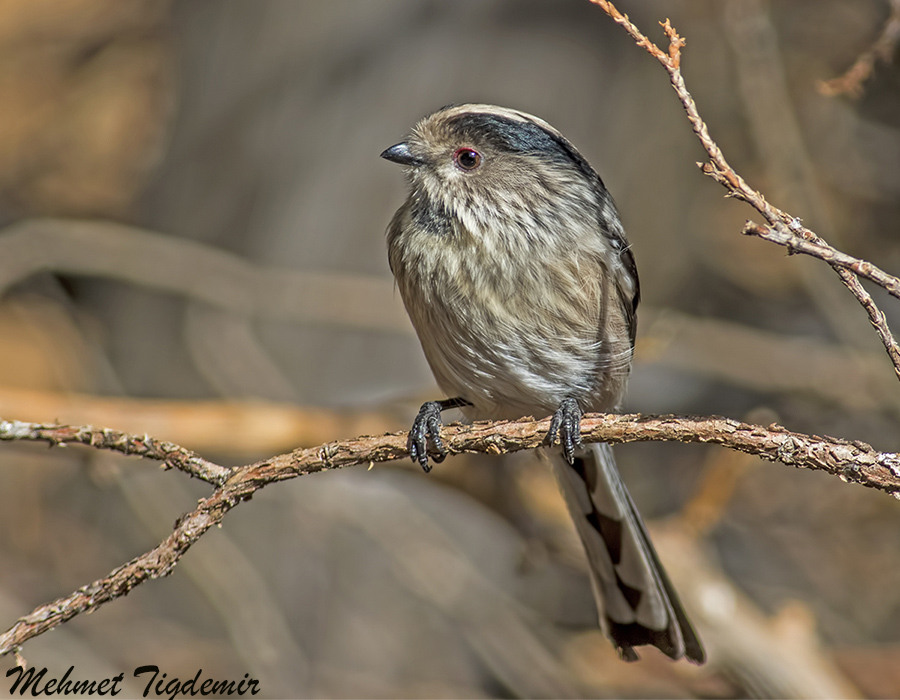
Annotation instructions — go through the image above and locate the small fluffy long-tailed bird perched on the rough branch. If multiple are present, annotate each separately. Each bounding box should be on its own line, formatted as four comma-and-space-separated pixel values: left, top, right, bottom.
381, 104, 705, 664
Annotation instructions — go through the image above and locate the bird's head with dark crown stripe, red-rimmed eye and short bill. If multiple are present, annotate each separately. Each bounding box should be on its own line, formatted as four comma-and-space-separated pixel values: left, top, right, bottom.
381, 104, 607, 237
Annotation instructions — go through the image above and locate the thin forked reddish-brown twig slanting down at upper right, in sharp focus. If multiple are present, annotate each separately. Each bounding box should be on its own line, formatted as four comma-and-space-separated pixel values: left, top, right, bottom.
590, 0, 900, 378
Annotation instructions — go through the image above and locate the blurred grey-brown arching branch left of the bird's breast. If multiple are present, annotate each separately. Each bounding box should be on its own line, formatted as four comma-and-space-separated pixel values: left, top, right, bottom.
0, 219, 412, 333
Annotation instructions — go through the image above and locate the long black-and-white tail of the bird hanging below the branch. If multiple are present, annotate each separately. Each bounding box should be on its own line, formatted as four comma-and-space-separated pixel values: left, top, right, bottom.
548, 444, 706, 664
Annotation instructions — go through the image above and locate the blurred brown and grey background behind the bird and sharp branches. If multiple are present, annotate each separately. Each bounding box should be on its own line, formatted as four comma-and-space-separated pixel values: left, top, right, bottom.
0, 0, 900, 698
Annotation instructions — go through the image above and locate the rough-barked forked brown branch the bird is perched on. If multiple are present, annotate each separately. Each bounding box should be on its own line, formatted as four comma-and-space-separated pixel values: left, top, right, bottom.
0, 414, 900, 655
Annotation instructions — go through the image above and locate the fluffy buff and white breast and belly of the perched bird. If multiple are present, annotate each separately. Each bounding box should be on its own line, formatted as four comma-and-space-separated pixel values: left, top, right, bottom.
391, 226, 631, 419
